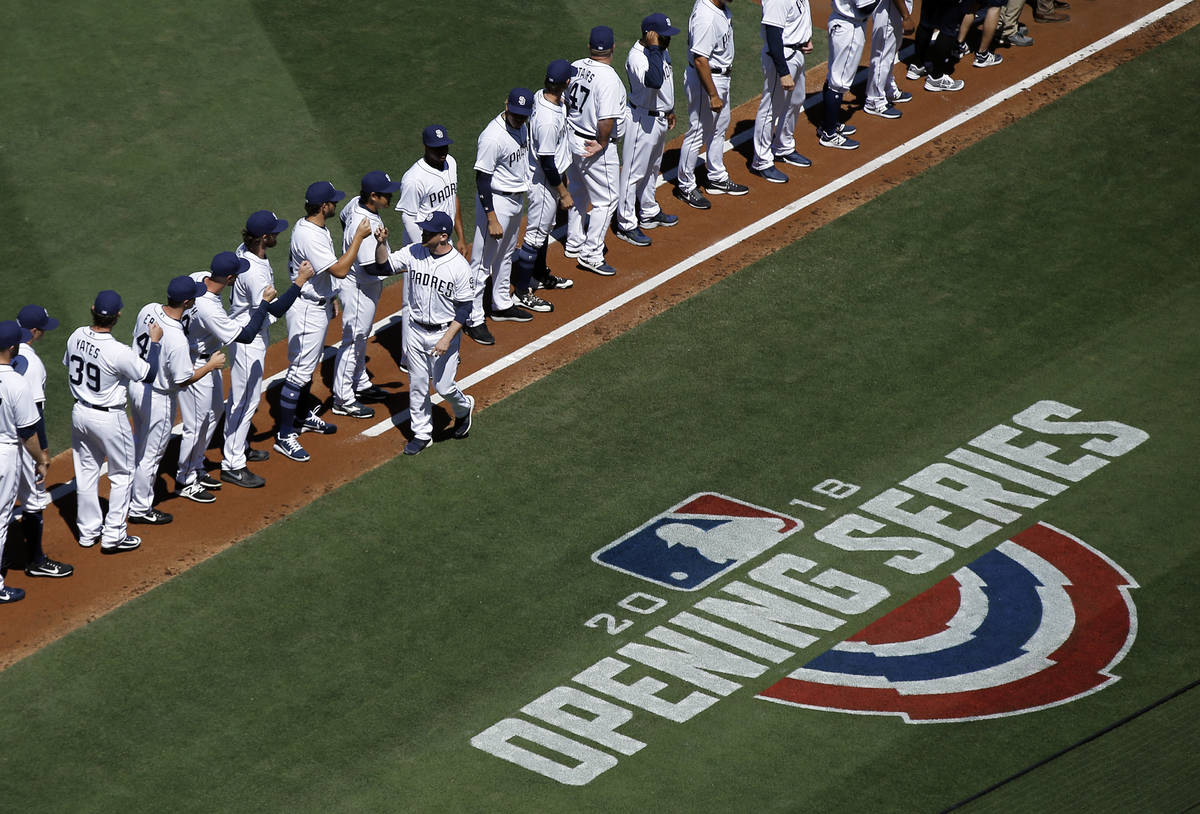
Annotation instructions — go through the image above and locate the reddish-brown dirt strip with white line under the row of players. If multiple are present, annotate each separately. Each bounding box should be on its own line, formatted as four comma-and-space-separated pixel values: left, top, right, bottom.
0, 0, 1200, 668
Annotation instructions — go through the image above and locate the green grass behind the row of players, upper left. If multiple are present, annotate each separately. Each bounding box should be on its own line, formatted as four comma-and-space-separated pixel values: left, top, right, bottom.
0, 0, 801, 451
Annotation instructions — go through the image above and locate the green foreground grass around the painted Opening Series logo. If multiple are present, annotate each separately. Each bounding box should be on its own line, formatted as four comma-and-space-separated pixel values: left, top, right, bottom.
0, 19, 1200, 812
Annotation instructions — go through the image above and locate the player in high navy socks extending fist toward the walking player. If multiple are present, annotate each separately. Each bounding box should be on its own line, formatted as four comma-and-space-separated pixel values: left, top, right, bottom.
275, 181, 371, 462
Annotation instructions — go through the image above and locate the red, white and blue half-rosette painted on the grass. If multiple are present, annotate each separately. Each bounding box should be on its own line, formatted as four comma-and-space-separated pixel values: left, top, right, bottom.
758, 523, 1138, 723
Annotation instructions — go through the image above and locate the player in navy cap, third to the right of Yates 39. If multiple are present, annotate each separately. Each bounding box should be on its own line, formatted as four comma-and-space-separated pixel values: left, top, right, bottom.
221, 209, 300, 487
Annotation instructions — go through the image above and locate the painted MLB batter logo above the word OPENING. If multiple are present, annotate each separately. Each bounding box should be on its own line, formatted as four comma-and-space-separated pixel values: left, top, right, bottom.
592, 492, 804, 591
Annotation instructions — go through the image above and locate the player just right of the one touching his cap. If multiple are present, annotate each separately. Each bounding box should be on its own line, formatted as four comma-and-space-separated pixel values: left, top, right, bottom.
674, 0, 750, 209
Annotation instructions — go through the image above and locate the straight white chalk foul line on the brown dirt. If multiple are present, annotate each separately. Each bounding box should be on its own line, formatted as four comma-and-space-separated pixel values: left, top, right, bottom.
361, 0, 1193, 437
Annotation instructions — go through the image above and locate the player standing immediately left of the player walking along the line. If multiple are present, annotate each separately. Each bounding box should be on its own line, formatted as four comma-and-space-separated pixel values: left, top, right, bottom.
334, 169, 400, 419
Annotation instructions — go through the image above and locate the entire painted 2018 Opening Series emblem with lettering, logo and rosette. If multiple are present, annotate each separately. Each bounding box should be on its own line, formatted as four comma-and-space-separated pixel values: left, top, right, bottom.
470, 400, 1150, 785
